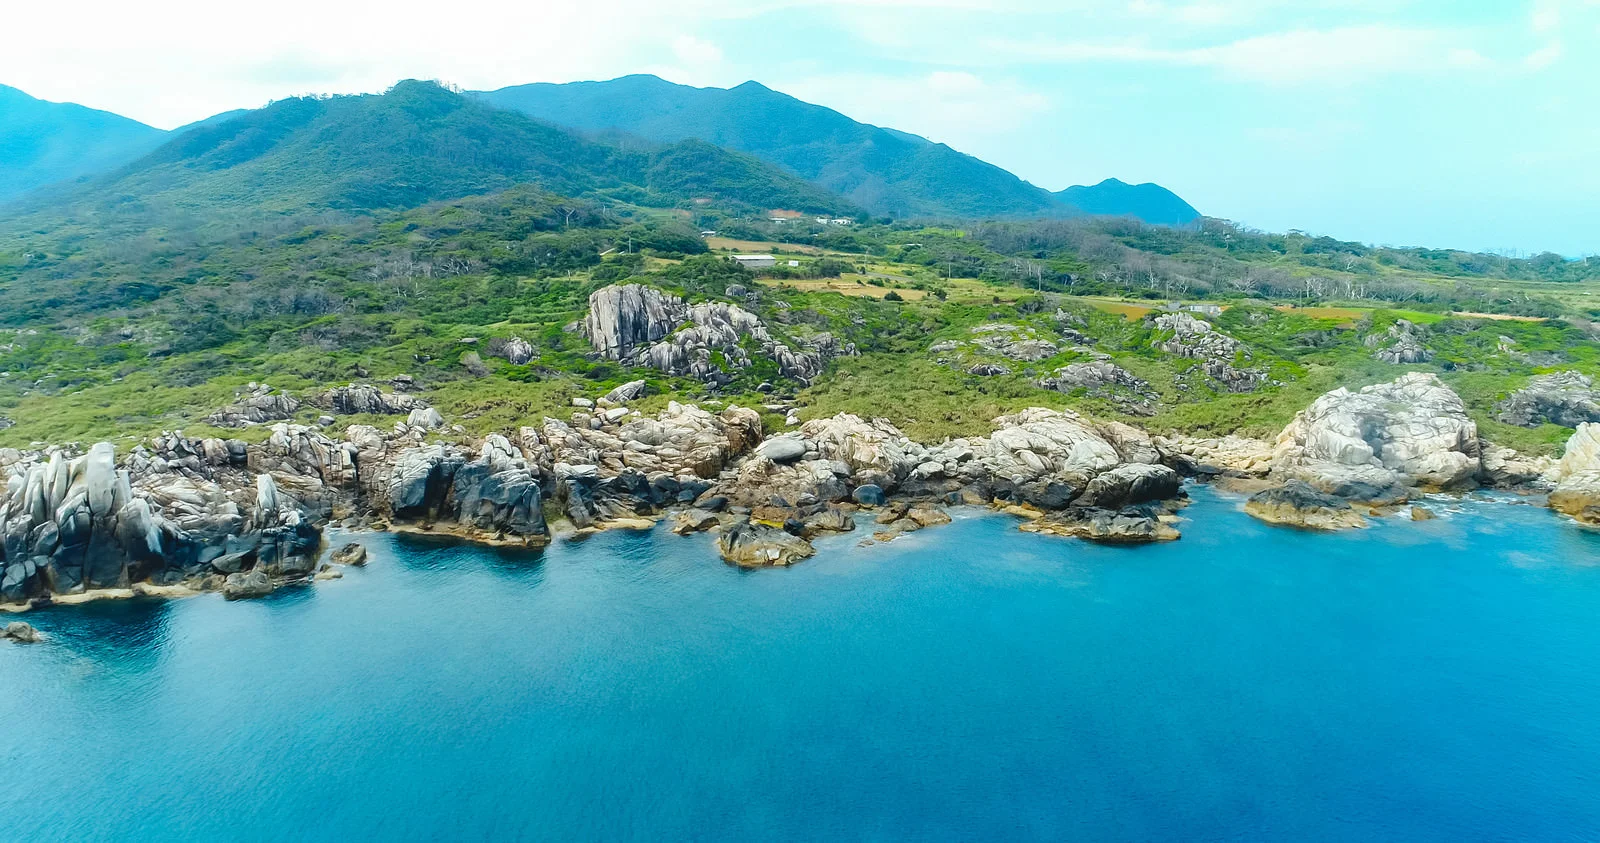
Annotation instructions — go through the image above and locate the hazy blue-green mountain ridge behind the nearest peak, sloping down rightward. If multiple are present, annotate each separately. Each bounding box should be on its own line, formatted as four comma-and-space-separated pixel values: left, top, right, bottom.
477, 75, 1198, 222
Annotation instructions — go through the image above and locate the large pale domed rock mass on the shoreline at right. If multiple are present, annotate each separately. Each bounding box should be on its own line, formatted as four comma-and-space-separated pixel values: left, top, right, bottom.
1272, 373, 1482, 499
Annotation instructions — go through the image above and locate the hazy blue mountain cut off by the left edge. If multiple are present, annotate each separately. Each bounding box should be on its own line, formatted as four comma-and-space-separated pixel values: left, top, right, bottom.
0, 85, 166, 202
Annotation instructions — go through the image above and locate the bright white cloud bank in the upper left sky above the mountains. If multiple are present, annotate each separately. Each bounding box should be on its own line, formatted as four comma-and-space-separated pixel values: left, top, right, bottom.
0, 0, 728, 126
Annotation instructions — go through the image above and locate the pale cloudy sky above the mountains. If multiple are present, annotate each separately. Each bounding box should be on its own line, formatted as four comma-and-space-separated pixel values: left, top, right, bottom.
0, 0, 1600, 256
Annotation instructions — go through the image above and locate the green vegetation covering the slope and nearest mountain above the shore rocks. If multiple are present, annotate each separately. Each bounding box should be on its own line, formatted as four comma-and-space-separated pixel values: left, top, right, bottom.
0, 83, 1600, 451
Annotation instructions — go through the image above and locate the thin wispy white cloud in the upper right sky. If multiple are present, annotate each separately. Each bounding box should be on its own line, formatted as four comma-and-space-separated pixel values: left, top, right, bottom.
990, 24, 1488, 85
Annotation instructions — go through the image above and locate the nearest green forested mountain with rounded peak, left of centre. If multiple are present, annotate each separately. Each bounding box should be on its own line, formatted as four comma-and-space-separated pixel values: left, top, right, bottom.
37, 80, 853, 213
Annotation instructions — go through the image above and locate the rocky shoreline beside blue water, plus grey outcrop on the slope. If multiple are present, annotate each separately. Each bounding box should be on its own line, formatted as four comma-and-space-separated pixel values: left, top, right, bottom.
9, 288, 1600, 611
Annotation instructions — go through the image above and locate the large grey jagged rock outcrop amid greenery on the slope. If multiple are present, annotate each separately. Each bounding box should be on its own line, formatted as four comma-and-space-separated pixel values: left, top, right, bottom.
582, 285, 854, 384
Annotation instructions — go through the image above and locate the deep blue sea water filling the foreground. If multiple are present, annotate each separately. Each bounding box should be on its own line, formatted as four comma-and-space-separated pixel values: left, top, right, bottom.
0, 489, 1600, 841
